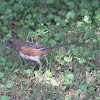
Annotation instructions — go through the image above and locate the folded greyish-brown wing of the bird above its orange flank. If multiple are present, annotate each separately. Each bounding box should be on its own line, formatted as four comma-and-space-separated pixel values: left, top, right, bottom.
22, 42, 47, 50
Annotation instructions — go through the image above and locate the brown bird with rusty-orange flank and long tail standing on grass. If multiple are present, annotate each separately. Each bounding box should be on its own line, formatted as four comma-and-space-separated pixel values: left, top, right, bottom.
4, 37, 76, 68
